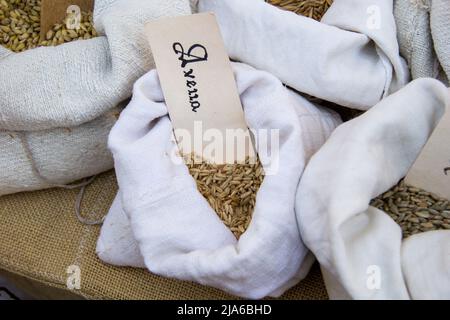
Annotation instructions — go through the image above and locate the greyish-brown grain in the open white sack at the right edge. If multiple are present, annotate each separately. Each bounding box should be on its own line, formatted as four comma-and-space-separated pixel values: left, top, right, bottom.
371, 180, 450, 238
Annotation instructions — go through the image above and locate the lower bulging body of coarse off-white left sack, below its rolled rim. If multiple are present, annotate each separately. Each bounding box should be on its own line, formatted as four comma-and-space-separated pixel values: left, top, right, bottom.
0, 108, 121, 196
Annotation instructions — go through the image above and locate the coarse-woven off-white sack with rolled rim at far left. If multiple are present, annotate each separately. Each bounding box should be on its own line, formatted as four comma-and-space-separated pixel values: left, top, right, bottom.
0, 0, 190, 195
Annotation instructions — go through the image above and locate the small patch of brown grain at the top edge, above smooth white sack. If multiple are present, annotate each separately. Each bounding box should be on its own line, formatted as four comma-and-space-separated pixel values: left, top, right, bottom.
267, 0, 333, 21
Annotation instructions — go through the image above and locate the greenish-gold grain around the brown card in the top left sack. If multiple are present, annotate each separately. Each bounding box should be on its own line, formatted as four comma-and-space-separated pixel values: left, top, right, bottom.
0, 0, 97, 52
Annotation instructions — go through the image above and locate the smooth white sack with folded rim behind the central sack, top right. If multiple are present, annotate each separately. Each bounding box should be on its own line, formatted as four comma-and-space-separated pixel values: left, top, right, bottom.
199, 0, 409, 110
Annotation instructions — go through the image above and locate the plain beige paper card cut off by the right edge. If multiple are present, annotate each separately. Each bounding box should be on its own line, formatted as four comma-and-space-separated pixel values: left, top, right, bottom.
405, 92, 450, 200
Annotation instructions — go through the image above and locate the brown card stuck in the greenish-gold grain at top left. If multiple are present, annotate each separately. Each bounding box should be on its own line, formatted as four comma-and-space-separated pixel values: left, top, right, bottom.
41, 0, 94, 39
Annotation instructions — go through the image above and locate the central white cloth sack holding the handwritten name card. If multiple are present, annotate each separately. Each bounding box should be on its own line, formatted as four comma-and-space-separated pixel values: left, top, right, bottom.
97, 64, 340, 299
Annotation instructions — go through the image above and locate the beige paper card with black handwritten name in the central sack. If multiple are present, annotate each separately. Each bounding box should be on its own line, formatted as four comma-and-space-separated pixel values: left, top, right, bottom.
145, 13, 255, 163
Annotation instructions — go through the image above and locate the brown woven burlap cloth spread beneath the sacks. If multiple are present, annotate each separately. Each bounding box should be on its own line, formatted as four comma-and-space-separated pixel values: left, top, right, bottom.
0, 172, 327, 300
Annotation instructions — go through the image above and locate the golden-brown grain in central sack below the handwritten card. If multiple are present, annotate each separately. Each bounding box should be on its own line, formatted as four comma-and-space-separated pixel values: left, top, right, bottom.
187, 158, 264, 239
